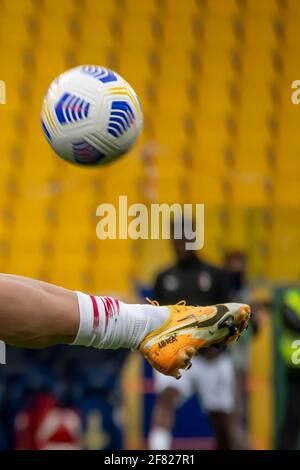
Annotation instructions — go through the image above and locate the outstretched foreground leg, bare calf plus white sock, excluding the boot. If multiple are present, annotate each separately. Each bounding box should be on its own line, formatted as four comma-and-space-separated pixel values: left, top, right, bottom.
0, 274, 169, 349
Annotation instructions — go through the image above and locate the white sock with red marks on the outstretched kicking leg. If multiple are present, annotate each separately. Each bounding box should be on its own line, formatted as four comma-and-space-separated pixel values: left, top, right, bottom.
72, 292, 169, 349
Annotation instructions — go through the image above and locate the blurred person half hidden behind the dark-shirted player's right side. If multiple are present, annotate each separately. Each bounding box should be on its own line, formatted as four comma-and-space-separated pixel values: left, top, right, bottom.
224, 250, 258, 449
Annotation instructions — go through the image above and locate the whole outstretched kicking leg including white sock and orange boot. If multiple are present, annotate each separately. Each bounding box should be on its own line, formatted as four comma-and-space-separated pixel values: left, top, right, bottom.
0, 274, 250, 378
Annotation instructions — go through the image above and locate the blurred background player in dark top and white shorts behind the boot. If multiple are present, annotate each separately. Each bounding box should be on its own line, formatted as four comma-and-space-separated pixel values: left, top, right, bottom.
149, 220, 236, 450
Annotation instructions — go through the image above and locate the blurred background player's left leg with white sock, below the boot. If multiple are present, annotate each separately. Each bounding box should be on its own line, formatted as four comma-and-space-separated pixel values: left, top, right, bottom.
148, 369, 193, 450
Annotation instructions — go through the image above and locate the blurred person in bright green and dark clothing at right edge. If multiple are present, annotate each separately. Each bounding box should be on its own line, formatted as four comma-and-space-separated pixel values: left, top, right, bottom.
279, 288, 300, 450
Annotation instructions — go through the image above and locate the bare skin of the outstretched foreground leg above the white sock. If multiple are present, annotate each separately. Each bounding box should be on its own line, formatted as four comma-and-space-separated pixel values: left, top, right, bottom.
0, 274, 79, 348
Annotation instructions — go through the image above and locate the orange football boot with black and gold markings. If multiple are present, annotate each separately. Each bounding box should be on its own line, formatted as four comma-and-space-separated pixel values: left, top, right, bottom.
139, 301, 251, 379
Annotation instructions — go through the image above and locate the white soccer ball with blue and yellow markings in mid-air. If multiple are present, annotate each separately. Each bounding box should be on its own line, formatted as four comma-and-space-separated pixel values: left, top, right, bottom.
41, 65, 143, 166
